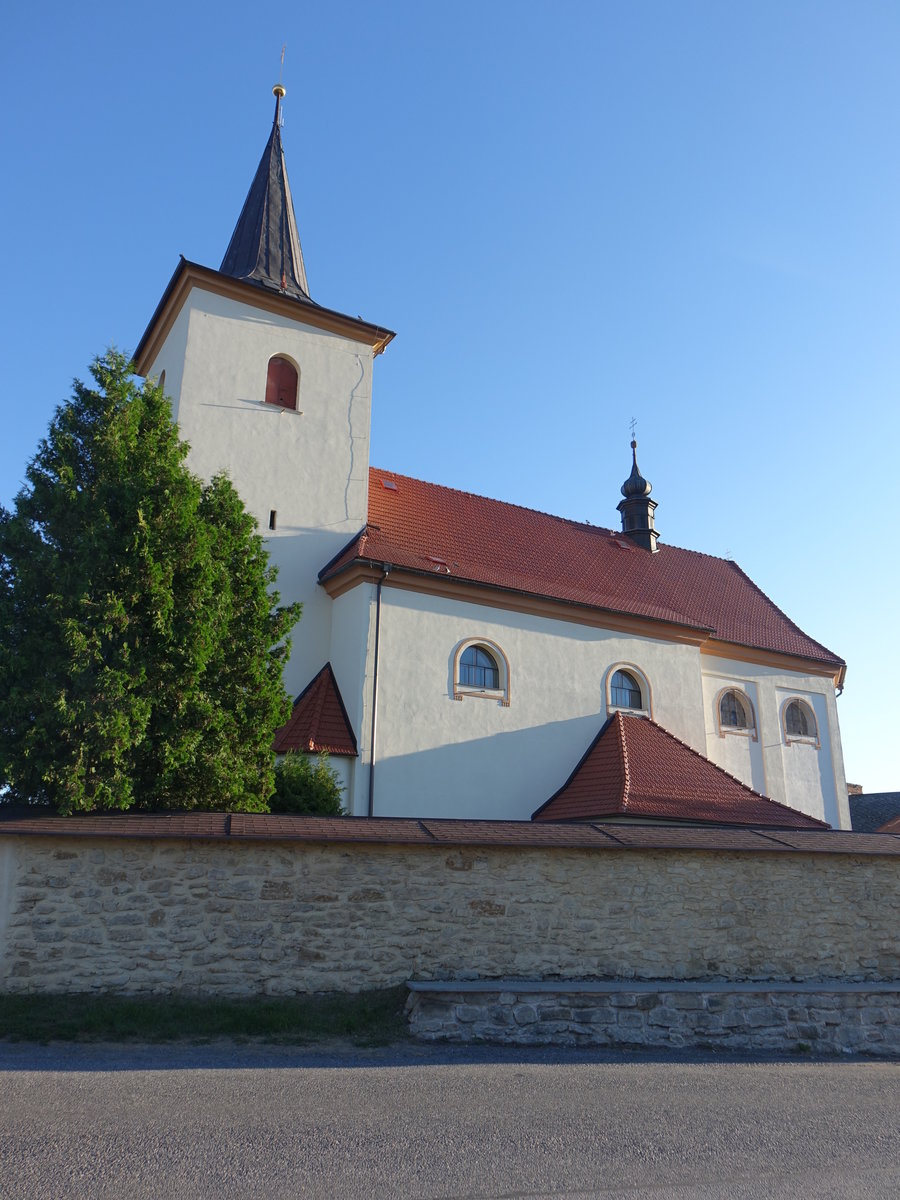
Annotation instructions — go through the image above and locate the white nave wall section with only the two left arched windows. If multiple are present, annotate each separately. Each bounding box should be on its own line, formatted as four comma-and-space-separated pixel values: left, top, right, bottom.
355, 580, 706, 820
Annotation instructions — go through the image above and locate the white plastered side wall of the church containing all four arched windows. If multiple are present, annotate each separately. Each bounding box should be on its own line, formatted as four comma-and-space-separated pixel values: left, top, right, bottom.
331, 578, 850, 828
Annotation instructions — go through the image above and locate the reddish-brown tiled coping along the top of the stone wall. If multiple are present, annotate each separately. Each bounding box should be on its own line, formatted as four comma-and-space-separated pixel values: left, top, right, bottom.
0, 809, 900, 856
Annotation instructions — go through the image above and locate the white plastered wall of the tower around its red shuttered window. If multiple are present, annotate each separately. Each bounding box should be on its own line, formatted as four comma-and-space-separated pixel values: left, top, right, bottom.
143, 288, 373, 697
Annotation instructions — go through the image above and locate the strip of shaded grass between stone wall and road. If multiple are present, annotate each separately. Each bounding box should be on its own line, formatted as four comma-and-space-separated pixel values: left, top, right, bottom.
0, 988, 408, 1046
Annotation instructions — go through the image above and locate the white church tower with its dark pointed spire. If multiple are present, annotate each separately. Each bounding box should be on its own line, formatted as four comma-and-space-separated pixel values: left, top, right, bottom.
134, 84, 394, 695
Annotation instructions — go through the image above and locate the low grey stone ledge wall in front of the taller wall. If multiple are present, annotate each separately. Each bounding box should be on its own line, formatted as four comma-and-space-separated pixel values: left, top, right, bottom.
407, 979, 900, 1056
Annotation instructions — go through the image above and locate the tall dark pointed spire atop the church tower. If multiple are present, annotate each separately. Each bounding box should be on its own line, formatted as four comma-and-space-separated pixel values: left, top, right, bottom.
220, 83, 312, 302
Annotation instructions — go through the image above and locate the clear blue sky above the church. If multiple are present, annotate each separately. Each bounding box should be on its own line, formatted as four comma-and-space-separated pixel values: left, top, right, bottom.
0, 0, 900, 791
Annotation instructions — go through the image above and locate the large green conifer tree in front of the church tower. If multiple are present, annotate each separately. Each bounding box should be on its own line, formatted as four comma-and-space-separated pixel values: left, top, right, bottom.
0, 350, 300, 812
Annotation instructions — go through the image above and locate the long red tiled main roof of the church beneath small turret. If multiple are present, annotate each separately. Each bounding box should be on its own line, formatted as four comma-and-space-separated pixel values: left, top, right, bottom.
319, 468, 844, 668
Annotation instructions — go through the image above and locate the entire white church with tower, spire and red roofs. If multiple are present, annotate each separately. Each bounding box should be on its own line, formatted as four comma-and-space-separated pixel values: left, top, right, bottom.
134, 85, 850, 829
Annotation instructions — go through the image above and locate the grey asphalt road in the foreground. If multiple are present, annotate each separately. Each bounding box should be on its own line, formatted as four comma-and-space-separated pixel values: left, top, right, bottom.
0, 1044, 900, 1200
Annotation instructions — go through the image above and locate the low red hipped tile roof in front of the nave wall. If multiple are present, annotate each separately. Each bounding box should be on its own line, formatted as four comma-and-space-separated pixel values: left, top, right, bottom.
532, 713, 828, 829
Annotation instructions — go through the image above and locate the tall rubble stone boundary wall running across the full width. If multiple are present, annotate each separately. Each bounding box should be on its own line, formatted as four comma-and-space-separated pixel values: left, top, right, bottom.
0, 817, 900, 998
